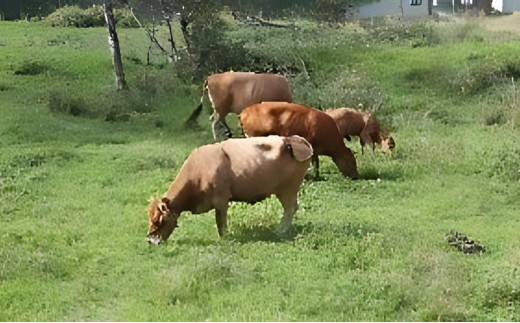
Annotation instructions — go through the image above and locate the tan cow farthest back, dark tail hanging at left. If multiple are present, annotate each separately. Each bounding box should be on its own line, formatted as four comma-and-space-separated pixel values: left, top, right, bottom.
186, 71, 292, 141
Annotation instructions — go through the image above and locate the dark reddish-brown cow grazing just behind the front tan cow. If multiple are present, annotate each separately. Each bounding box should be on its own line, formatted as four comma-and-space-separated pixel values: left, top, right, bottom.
239, 102, 359, 179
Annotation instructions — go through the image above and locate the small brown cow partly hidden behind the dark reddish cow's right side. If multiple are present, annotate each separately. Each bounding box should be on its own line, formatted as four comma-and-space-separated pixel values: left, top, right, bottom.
325, 108, 395, 153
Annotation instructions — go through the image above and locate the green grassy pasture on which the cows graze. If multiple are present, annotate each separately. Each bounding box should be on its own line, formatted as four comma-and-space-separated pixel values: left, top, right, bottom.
0, 15, 520, 321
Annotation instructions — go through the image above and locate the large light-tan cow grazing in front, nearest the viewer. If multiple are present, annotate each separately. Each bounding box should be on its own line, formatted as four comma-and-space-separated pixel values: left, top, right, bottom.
147, 136, 313, 244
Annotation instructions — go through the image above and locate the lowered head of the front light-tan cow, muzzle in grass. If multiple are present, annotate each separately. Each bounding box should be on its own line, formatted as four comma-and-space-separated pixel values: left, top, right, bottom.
146, 197, 179, 244
